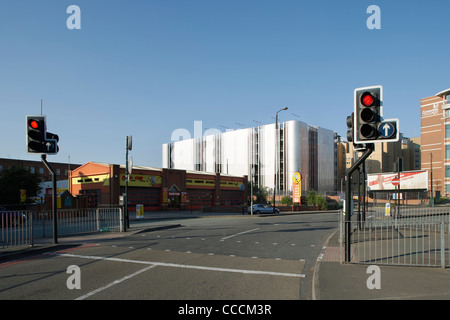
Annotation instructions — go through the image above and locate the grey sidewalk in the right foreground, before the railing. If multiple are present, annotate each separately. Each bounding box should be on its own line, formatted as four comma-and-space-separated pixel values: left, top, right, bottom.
313, 232, 450, 300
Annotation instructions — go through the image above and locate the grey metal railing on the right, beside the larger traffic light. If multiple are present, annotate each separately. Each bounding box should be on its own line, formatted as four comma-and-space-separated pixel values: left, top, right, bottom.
339, 207, 450, 268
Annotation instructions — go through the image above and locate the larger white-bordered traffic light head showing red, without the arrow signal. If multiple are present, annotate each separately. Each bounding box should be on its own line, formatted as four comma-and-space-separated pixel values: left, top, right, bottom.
353, 86, 383, 143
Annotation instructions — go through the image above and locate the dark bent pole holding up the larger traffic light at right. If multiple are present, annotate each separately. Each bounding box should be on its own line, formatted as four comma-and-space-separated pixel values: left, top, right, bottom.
345, 143, 375, 262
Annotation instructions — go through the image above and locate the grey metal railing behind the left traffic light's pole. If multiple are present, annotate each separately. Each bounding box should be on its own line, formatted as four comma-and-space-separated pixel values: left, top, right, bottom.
0, 208, 123, 249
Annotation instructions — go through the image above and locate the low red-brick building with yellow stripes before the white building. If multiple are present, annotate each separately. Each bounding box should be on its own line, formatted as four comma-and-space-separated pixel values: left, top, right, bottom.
69, 162, 247, 210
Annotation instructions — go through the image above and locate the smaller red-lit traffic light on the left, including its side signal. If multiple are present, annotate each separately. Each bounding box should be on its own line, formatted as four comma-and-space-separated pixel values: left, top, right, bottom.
26, 115, 59, 154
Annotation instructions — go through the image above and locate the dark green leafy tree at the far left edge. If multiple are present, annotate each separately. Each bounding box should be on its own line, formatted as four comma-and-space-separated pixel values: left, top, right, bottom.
0, 166, 41, 205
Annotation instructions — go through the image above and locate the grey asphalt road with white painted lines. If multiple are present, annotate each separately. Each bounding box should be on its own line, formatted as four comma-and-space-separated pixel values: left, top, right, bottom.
0, 212, 337, 300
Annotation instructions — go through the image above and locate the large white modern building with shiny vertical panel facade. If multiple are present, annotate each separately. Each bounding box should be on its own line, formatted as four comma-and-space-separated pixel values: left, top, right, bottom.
162, 120, 337, 195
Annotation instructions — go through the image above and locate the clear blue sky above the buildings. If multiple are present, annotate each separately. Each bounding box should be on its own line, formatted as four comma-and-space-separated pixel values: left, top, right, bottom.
0, 0, 450, 167
